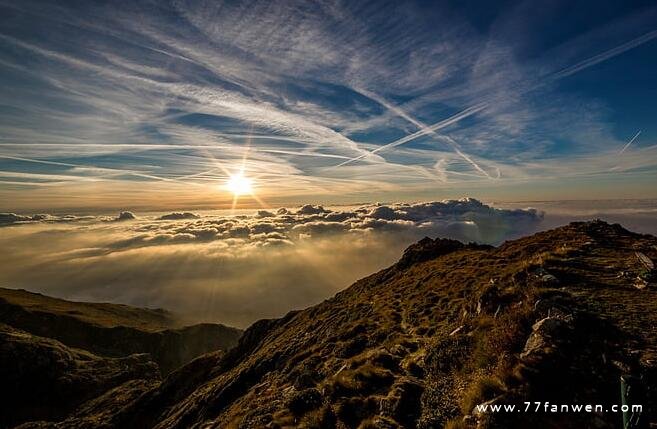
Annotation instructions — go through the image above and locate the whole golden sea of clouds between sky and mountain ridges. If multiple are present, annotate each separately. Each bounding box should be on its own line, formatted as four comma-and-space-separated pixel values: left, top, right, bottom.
0, 198, 543, 327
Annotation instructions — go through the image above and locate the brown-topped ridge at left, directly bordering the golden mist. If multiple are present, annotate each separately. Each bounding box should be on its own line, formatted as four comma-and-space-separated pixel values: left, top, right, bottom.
0, 288, 241, 374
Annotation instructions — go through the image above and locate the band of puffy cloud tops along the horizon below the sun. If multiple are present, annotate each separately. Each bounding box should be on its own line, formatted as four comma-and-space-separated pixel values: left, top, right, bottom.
0, 198, 543, 246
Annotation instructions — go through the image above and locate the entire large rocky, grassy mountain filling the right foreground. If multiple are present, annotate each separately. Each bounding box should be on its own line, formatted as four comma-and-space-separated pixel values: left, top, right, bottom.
5, 221, 657, 429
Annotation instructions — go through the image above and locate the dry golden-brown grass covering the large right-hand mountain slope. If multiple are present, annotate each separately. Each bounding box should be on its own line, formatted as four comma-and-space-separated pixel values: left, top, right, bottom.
9, 223, 657, 429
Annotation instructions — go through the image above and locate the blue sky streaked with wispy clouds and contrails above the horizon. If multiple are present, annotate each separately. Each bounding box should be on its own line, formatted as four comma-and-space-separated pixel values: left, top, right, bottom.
0, 0, 657, 211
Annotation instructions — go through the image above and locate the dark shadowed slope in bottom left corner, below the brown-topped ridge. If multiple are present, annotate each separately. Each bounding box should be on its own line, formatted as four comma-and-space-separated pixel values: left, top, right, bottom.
0, 324, 160, 428
